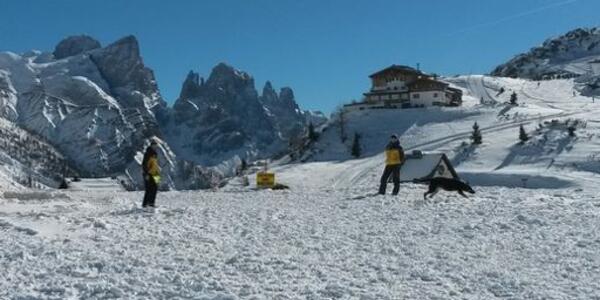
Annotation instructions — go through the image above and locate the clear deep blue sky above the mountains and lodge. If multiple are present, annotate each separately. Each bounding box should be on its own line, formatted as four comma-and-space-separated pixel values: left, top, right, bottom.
0, 0, 600, 112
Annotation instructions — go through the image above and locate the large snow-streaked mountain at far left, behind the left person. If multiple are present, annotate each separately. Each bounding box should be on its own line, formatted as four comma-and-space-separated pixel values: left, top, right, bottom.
0, 36, 213, 188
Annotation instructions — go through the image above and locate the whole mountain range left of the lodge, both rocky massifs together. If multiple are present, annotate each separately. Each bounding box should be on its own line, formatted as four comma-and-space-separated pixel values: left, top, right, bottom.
0, 36, 324, 189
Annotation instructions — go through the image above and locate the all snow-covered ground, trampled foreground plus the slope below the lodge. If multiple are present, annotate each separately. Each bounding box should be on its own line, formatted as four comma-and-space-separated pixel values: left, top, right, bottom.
0, 76, 600, 299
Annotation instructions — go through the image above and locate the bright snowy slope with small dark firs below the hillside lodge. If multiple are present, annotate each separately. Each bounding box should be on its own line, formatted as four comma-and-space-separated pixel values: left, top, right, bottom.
264, 76, 600, 192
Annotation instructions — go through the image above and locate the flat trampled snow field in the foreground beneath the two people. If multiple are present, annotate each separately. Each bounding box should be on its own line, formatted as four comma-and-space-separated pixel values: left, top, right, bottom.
0, 185, 600, 299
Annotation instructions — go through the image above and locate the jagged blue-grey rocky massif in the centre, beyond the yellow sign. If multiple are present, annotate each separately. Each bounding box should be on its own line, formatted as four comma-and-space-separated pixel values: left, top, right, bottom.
163, 63, 307, 166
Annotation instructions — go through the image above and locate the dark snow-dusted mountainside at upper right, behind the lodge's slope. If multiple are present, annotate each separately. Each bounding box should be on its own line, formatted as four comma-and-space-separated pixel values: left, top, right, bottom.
491, 27, 600, 95
